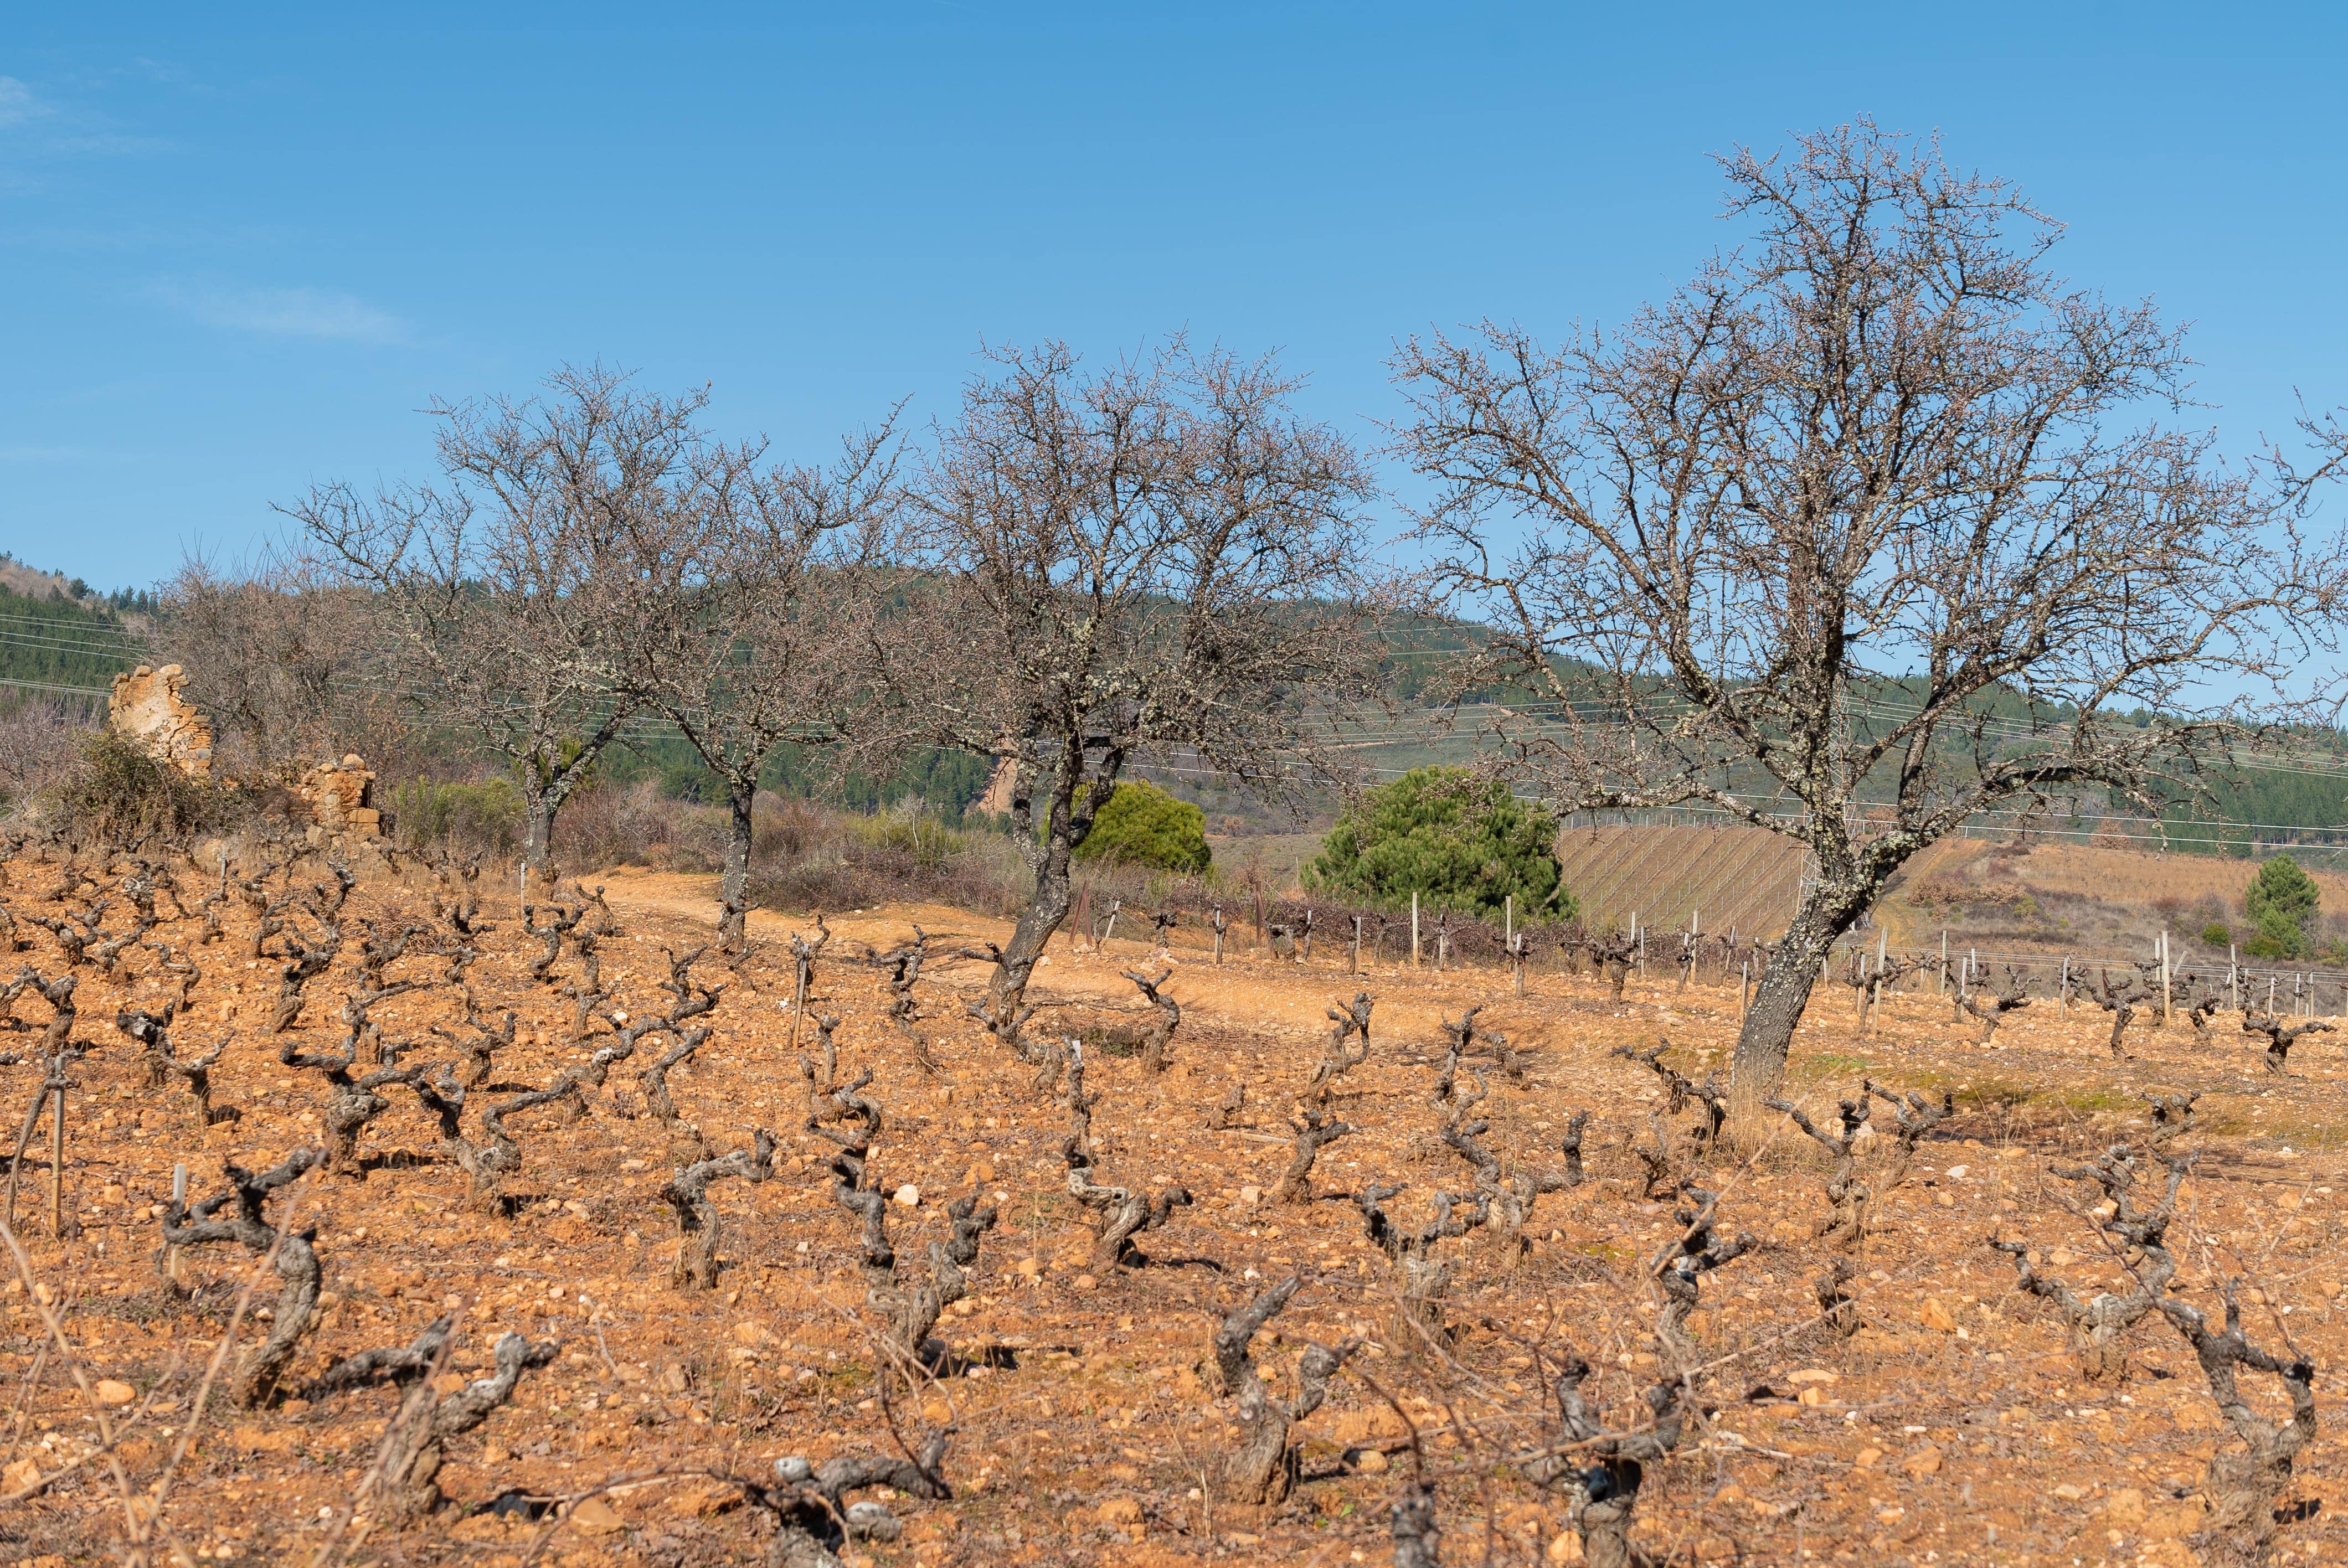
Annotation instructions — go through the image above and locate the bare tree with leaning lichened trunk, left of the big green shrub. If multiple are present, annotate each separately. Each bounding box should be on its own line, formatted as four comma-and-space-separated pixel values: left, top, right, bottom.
876, 338, 1376, 1030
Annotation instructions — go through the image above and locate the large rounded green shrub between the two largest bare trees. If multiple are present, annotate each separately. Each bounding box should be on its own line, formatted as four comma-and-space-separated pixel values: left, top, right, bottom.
1303, 767, 1573, 920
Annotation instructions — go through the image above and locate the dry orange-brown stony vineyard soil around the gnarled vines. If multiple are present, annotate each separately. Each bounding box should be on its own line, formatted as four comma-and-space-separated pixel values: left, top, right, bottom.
0, 864, 2348, 1568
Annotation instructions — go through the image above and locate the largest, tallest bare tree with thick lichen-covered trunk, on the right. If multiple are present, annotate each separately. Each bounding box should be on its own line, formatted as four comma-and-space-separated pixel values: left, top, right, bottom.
1395, 122, 2348, 1106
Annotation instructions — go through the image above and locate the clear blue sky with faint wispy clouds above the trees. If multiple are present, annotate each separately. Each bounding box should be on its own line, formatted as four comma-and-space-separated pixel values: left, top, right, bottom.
0, 0, 2348, 587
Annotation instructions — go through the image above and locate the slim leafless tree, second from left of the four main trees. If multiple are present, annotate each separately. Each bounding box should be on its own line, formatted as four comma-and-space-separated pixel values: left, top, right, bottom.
617, 415, 899, 951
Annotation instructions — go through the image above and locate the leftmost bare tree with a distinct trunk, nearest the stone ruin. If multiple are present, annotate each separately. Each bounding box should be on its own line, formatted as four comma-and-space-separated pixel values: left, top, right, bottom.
284, 366, 707, 875
